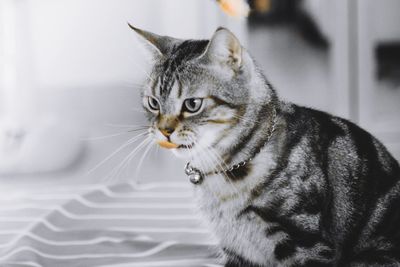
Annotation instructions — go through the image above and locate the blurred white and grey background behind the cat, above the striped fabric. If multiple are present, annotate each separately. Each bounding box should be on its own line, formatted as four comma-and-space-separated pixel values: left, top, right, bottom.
0, 0, 400, 187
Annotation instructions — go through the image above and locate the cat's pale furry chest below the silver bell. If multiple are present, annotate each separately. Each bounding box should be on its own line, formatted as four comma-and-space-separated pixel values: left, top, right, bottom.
196, 175, 276, 266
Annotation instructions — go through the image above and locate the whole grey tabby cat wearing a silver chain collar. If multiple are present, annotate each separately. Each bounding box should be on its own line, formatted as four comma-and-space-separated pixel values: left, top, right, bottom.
130, 25, 400, 267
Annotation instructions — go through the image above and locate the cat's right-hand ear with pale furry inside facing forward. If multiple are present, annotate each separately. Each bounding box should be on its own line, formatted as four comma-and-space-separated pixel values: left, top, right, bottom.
201, 27, 243, 70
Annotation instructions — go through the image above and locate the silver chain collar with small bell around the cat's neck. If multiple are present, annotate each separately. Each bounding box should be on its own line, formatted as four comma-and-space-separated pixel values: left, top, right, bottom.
185, 109, 277, 184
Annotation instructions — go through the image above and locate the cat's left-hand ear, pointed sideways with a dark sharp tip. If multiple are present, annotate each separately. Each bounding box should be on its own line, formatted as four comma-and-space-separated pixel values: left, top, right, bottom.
128, 23, 181, 56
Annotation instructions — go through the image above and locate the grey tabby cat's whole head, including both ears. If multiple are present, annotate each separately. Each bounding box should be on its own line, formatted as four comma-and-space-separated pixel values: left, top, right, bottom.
130, 25, 272, 168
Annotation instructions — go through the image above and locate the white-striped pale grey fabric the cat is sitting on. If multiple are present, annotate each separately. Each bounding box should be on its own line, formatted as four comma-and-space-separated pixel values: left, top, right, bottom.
0, 183, 221, 267
